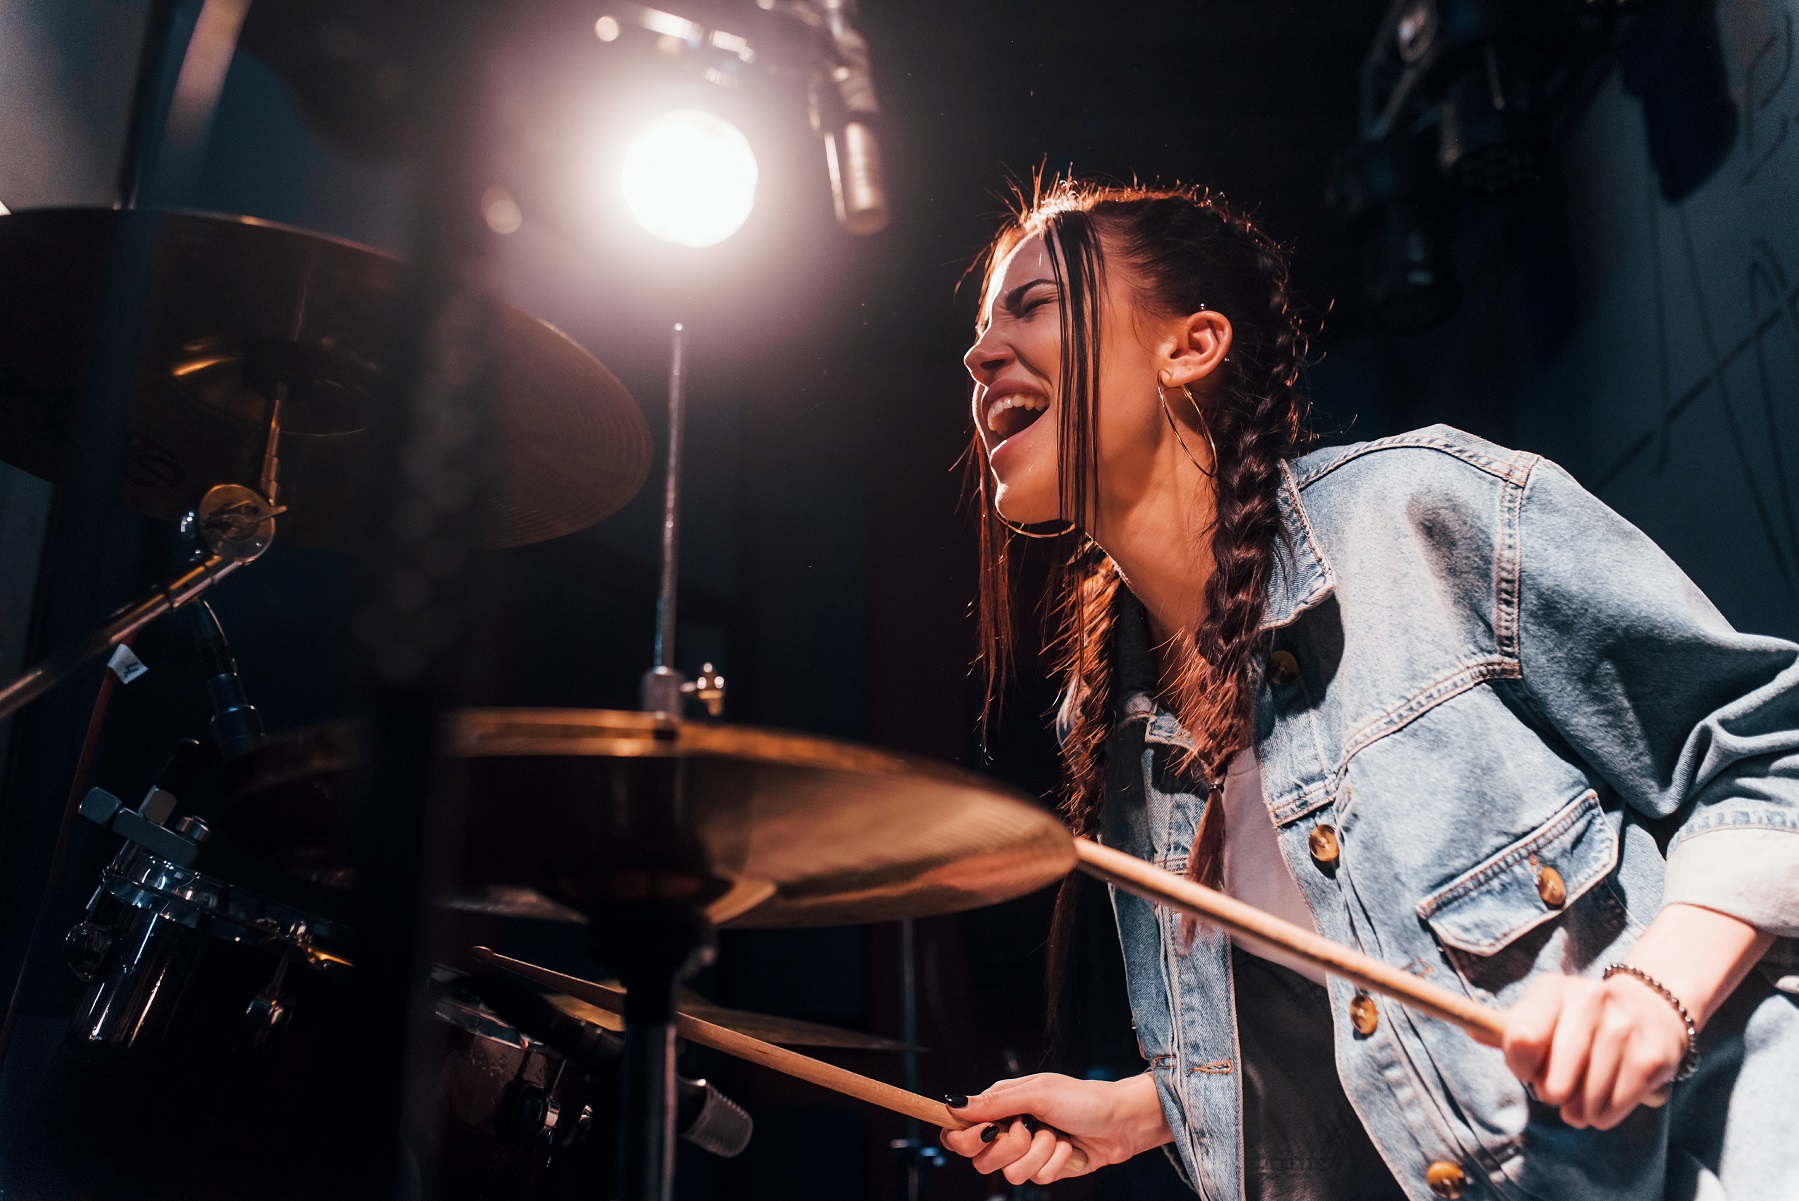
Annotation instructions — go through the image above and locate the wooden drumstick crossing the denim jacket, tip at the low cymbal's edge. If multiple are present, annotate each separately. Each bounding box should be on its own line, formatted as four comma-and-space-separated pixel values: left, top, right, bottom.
1074, 838, 1668, 1108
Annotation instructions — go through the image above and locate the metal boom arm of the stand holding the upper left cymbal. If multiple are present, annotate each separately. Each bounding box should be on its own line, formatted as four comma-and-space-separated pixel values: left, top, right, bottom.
0, 406, 284, 719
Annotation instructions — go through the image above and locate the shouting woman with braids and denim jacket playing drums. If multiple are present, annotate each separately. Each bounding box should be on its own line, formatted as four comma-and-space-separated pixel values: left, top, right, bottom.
944, 183, 1799, 1201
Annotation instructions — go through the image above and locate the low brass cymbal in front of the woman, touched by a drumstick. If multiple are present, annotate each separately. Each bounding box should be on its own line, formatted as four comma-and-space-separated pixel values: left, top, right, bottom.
218, 708, 1074, 926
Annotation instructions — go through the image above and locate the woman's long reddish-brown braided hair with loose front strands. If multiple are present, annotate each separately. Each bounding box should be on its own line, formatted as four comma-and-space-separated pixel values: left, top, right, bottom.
970, 180, 1311, 1007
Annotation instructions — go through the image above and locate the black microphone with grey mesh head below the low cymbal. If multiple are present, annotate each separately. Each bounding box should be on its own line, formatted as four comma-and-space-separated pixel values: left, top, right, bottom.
464, 974, 756, 1160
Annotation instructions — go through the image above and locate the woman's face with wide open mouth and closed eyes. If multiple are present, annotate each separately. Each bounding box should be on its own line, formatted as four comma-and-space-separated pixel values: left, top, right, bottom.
962, 234, 1229, 536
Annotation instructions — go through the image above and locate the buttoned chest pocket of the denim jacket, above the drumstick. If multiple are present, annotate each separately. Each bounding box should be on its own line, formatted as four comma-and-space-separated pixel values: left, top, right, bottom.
1418, 789, 1630, 1003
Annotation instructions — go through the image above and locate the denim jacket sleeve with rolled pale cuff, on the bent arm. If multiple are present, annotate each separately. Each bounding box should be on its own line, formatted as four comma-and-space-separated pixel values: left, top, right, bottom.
1518, 462, 1799, 937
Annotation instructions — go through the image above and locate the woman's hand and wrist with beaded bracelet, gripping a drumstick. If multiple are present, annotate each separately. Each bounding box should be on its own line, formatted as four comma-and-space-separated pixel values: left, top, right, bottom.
1504, 904, 1772, 1131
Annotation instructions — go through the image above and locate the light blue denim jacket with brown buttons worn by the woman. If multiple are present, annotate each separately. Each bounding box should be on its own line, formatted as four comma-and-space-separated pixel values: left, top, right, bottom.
1101, 426, 1799, 1201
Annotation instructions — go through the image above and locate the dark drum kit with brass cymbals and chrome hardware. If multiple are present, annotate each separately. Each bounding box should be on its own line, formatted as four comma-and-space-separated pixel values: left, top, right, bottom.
0, 199, 1074, 1197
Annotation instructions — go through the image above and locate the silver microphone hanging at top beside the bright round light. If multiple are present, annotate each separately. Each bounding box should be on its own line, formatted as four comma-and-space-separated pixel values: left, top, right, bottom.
810, 0, 889, 236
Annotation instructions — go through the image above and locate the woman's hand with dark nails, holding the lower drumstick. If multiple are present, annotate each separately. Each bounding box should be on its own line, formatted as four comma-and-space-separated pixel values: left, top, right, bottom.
943, 1072, 1175, 1185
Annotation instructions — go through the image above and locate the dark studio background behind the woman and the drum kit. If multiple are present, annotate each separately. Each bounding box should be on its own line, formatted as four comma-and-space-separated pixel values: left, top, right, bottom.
0, 0, 1799, 1199
